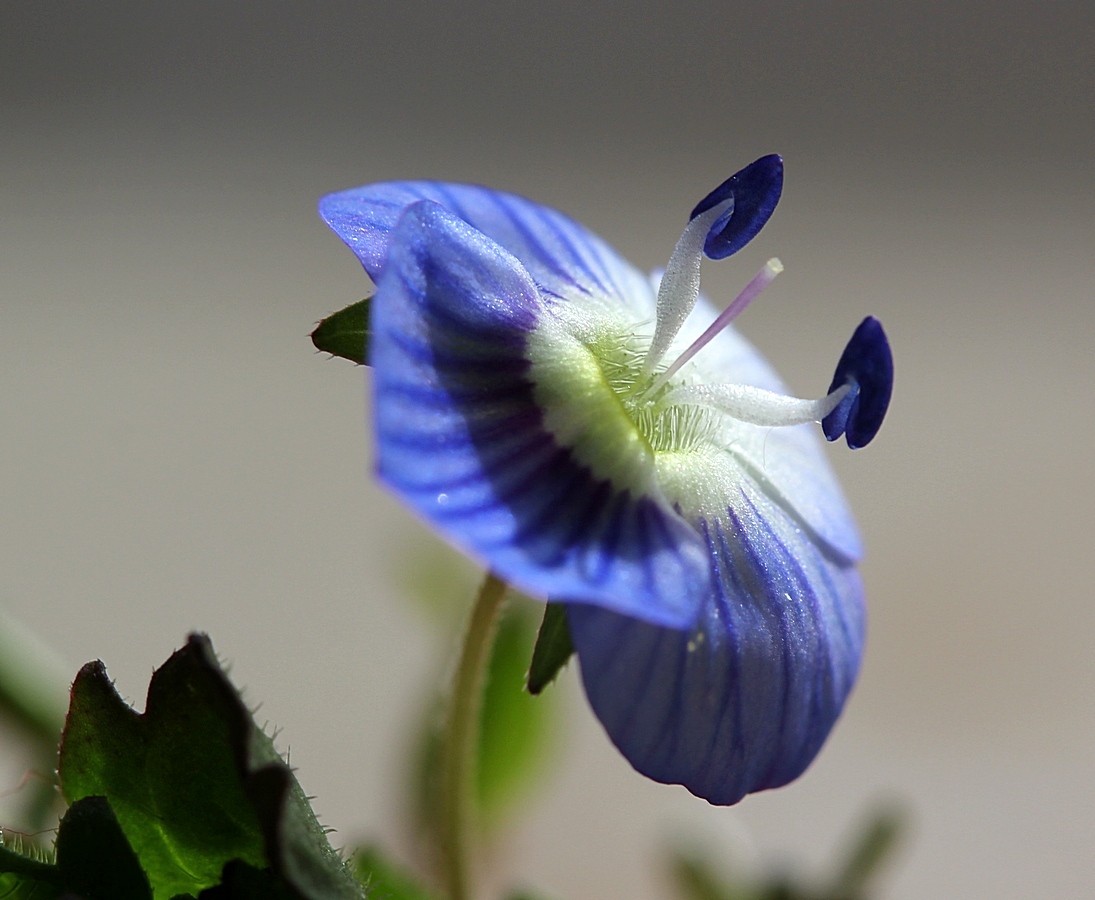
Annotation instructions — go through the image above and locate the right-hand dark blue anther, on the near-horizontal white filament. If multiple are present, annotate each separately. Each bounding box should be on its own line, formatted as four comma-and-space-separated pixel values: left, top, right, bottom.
821, 315, 894, 450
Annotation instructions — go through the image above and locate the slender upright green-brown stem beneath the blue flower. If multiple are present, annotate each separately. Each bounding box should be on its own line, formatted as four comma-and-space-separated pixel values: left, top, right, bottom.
441, 573, 506, 900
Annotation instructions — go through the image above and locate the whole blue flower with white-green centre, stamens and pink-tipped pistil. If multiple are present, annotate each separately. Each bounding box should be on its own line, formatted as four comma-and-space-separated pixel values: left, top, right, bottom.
320, 155, 892, 804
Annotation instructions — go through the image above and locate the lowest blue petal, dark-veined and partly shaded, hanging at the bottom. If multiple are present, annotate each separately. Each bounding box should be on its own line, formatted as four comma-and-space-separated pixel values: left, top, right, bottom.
567, 480, 864, 805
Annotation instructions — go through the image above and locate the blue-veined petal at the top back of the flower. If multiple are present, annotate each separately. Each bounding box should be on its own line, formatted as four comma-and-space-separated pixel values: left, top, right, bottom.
320, 181, 655, 320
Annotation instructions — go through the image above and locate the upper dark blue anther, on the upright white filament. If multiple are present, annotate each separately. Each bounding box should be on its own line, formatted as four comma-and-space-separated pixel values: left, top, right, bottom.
689, 153, 783, 259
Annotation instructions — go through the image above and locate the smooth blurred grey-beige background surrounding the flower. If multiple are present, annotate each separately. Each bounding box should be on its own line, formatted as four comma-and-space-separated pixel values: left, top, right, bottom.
0, 2, 1095, 900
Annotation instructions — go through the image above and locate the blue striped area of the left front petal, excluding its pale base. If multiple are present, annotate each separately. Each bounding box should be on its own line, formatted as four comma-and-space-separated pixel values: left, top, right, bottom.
372, 200, 711, 627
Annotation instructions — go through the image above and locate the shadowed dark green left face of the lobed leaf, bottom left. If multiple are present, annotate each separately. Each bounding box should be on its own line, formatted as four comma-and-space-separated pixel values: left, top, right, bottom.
59, 638, 266, 898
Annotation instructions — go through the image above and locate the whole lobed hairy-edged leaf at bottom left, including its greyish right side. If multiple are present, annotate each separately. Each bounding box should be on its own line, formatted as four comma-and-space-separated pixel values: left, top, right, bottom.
59, 635, 362, 900
